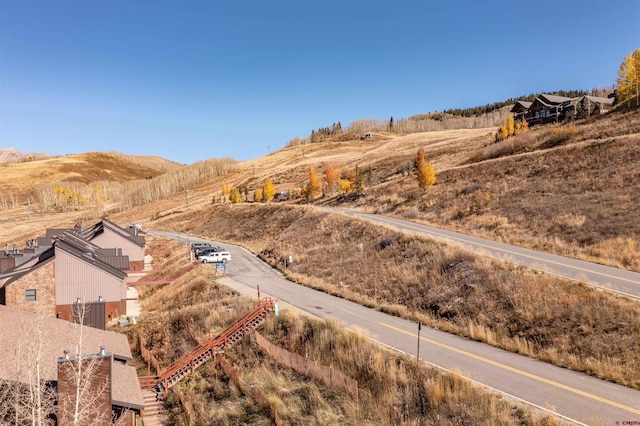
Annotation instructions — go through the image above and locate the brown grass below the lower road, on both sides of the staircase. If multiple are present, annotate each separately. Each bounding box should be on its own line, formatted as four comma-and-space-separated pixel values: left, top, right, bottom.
129, 241, 558, 425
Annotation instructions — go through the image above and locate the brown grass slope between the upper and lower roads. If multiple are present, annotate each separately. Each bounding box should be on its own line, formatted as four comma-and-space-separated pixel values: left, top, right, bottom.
152, 205, 640, 388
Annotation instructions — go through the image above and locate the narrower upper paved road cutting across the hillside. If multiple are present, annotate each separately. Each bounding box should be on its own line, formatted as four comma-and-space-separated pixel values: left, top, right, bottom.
326, 209, 640, 298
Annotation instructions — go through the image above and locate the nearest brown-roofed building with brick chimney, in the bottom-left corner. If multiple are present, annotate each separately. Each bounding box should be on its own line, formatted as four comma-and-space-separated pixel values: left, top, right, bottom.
0, 306, 144, 426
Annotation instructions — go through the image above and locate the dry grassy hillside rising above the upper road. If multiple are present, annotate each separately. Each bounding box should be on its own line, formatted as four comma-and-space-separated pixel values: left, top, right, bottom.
5, 111, 640, 270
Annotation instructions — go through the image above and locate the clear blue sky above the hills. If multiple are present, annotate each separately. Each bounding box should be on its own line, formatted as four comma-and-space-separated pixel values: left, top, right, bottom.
0, 0, 640, 164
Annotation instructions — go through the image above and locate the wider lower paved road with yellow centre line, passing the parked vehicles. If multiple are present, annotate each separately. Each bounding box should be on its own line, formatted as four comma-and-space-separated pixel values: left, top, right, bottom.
152, 231, 640, 425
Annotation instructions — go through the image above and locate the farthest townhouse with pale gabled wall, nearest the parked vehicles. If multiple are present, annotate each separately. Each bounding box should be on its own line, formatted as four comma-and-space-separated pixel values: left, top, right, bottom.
79, 218, 145, 271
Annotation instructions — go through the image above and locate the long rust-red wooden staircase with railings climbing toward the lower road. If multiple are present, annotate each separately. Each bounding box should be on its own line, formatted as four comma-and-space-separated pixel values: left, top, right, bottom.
140, 298, 276, 393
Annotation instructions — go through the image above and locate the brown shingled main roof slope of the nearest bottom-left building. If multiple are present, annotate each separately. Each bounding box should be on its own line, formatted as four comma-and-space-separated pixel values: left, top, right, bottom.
0, 305, 132, 383
